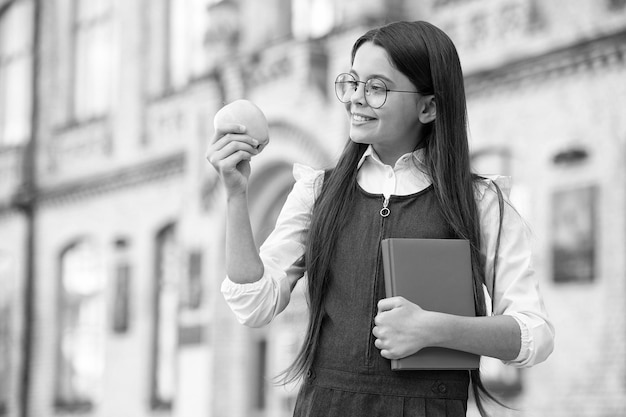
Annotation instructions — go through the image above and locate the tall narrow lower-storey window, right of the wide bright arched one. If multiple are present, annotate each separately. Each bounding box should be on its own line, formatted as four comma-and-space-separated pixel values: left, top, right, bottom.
151, 225, 179, 409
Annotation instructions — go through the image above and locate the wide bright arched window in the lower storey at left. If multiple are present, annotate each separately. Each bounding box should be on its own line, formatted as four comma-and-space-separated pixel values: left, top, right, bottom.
55, 241, 106, 410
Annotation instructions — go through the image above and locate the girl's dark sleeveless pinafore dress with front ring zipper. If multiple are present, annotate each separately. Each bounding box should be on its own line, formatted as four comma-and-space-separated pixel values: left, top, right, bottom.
294, 186, 469, 417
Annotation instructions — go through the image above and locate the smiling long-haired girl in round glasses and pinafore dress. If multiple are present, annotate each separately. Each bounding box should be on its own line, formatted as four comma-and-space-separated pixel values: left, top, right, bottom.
207, 22, 554, 416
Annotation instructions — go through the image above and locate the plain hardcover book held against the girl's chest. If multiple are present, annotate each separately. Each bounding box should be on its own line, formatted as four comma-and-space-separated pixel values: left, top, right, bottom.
381, 238, 480, 370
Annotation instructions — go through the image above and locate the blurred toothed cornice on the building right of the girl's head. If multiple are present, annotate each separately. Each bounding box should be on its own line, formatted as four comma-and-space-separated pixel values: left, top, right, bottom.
465, 30, 626, 97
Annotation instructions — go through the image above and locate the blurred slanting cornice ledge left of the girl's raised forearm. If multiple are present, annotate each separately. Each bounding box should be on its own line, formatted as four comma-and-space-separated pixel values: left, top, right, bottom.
37, 152, 185, 205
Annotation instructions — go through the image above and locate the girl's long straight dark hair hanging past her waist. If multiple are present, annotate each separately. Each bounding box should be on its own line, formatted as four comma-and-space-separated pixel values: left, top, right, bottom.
278, 22, 497, 415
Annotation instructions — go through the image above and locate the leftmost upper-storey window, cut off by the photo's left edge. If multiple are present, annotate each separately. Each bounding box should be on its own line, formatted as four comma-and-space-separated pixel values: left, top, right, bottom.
0, 0, 34, 146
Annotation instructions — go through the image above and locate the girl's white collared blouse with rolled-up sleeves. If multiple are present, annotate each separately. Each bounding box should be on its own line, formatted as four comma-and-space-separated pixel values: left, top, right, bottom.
221, 146, 554, 367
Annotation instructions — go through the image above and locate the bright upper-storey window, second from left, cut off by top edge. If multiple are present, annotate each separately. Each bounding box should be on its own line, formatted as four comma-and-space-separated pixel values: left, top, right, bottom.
71, 0, 114, 121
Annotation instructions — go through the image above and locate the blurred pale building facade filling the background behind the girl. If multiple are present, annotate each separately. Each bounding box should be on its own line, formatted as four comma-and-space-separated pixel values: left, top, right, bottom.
0, 0, 626, 417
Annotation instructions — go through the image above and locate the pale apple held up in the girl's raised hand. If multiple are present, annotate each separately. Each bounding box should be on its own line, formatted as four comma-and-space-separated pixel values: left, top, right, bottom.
213, 99, 269, 149
